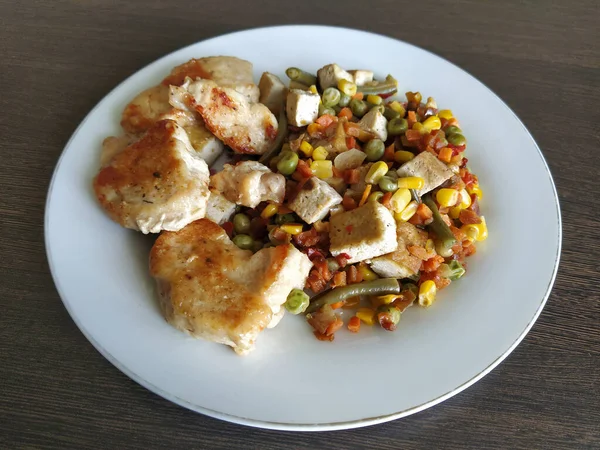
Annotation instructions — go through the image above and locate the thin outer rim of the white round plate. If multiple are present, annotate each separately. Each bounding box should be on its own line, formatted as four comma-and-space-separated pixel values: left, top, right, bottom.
44, 24, 563, 431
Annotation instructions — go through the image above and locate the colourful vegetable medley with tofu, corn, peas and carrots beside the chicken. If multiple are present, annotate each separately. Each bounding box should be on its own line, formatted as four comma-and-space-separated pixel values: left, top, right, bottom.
223, 64, 488, 341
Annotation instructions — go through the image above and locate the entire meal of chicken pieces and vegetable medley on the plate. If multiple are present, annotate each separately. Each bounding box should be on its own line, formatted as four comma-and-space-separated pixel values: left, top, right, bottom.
94, 56, 488, 354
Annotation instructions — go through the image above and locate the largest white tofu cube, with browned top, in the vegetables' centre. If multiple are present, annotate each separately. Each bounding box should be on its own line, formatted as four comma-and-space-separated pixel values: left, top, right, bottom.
329, 202, 398, 264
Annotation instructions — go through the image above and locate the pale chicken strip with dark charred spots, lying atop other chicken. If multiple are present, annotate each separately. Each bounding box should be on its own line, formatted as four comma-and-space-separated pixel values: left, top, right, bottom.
171, 79, 278, 155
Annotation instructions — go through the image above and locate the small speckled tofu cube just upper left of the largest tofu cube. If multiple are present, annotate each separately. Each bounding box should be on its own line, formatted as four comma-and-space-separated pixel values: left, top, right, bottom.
288, 177, 342, 223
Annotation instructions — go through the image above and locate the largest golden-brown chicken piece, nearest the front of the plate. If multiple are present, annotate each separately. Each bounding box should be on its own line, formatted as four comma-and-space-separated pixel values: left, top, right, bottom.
150, 219, 312, 355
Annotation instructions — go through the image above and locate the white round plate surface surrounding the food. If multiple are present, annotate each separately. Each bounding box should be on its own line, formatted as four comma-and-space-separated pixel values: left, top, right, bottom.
46, 26, 561, 430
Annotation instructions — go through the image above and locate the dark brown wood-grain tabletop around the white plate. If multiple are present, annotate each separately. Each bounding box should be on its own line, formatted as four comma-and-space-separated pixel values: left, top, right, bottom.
0, 0, 600, 449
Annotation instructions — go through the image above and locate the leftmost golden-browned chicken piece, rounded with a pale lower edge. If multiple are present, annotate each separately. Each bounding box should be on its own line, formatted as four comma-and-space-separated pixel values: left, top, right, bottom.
94, 120, 210, 233
